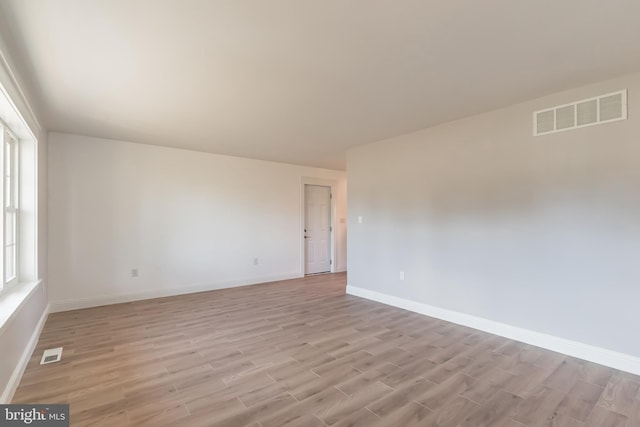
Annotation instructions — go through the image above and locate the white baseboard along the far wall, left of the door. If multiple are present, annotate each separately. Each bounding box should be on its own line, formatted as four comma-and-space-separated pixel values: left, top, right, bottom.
51, 274, 300, 313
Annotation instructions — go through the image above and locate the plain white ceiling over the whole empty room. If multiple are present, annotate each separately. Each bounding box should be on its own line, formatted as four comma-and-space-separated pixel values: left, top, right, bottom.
0, 0, 640, 169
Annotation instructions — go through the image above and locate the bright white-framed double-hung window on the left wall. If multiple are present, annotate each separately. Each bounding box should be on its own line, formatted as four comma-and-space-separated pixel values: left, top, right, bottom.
0, 123, 20, 290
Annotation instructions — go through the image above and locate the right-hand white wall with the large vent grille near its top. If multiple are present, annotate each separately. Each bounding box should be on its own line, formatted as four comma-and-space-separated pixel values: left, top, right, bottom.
347, 74, 640, 367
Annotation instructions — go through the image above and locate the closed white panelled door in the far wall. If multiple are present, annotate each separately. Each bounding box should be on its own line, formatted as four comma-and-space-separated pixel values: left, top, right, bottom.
304, 185, 331, 274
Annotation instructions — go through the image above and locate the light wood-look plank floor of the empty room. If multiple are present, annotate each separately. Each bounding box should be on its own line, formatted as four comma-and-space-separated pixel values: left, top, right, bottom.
14, 274, 640, 427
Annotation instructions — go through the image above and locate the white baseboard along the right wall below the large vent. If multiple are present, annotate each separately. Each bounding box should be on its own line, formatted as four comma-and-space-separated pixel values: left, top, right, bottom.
347, 286, 640, 375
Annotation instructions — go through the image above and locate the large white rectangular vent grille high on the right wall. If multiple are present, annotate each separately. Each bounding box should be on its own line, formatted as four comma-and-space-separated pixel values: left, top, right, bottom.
533, 89, 627, 136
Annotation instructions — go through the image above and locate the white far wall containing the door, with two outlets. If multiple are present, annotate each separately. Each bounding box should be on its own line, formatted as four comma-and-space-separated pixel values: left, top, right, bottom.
49, 133, 346, 310
